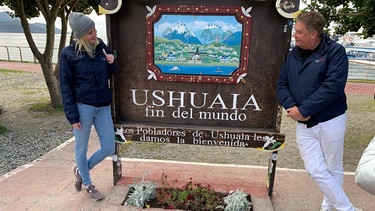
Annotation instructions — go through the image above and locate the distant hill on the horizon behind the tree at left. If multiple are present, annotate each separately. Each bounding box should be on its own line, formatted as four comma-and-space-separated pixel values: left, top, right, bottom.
0, 12, 61, 34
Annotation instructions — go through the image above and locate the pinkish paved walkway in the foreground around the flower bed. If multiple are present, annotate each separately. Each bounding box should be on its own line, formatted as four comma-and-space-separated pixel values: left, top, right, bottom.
0, 129, 375, 211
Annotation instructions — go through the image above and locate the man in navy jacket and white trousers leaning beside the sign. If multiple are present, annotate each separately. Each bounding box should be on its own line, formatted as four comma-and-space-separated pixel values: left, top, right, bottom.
276, 12, 361, 211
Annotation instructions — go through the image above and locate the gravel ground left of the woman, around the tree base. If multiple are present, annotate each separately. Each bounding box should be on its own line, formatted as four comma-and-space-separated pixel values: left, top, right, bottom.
0, 67, 72, 175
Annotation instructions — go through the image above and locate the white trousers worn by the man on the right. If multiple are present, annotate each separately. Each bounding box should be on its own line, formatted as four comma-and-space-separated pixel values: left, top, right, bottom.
296, 114, 354, 211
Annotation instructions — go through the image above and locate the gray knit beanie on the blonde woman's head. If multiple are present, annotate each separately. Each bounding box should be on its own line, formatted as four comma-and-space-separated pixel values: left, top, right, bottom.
68, 12, 95, 39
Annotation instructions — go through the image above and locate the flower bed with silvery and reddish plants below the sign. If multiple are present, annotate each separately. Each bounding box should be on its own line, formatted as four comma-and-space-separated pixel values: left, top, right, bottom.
123, 174, 252, 211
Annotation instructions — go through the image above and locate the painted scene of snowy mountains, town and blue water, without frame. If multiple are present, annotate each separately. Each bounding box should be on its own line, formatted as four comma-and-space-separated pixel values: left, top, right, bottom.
154, 14, 243, 76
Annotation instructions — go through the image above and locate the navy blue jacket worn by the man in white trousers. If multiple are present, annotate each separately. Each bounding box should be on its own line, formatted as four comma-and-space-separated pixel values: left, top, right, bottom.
276, 35, 348, 127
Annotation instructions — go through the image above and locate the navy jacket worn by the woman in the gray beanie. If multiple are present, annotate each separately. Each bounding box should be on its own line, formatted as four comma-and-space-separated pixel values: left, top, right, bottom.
60, 39, 115, 124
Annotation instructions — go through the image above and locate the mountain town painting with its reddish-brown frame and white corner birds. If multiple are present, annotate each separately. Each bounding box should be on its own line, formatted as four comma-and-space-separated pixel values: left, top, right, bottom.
146, 5, 252, 83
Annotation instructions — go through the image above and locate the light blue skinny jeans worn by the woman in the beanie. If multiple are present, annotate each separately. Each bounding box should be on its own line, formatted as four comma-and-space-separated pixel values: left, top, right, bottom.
74, 103, 115, 187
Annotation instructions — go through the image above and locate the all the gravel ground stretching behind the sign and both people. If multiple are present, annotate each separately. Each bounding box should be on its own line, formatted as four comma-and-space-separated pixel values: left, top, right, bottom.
0, 62, 375, 175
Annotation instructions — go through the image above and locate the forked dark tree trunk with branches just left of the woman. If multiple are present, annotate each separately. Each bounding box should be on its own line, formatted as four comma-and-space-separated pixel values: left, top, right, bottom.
11, 0, 98, 108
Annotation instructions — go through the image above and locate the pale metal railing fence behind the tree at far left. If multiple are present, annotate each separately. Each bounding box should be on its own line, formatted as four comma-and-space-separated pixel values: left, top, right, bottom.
0, 45, 58, 63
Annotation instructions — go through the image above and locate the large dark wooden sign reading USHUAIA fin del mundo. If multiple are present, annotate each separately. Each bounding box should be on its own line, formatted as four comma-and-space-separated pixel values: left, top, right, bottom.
101, 0, 299, 194
